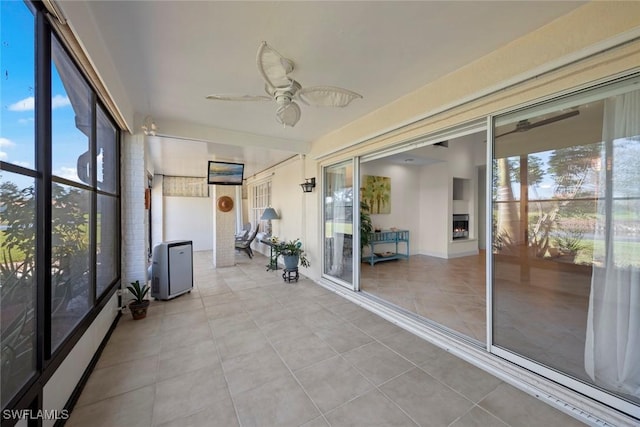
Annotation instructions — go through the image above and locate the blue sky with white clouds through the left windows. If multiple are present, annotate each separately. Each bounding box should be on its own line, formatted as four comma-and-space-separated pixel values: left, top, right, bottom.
0, 0, 87, 186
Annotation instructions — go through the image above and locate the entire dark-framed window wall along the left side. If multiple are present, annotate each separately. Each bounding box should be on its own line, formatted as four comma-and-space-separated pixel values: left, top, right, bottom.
0, 2, 120, 418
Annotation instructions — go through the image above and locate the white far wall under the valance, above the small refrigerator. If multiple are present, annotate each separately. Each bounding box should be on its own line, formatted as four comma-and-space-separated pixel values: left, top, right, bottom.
163, 197, 214, 251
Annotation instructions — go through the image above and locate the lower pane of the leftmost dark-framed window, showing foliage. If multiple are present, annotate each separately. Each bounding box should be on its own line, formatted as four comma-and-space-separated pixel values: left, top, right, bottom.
0, 171, 36, 407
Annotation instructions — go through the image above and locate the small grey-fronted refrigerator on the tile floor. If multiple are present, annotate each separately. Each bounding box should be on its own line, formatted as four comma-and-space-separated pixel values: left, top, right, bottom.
151, 240, 193, 300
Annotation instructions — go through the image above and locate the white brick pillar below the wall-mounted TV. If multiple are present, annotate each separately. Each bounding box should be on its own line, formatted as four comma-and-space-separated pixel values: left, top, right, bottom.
211, 185, 238, 268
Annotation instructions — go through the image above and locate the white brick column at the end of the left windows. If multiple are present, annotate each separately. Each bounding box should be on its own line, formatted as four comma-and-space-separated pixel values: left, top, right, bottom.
120, 134, 147, 289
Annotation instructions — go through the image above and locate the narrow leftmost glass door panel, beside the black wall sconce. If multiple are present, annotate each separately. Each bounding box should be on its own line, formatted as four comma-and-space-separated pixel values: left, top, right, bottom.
323, 162, 355, 289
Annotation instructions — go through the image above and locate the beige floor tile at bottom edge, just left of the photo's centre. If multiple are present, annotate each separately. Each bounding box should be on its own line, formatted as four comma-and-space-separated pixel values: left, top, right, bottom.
234, 375, 320, 427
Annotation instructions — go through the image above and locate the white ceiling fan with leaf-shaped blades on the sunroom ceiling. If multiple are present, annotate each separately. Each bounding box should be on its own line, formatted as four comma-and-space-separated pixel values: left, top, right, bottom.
207, 41, 362, 127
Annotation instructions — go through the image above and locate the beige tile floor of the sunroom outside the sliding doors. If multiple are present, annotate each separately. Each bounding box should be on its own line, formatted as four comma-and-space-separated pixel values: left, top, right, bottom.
67, 252, 581, 427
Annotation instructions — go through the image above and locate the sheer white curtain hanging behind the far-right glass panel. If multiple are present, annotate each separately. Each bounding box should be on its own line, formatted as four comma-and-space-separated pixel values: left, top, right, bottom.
585, 91, 640, 397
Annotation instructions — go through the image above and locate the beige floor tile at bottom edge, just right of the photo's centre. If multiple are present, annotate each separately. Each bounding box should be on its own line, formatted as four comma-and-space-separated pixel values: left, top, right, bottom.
325, 390, 417, 427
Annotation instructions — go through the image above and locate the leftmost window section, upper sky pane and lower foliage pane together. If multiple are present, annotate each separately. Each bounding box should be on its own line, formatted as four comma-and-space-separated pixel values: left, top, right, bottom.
0, 1, 37, 408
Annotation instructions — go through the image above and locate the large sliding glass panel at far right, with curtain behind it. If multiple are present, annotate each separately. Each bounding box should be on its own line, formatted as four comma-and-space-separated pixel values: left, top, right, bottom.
493, 78, 640, 410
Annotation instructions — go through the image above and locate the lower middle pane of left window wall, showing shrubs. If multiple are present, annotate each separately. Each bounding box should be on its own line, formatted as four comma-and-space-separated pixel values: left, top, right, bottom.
51, 183, 92, 351
